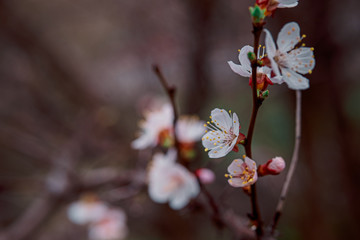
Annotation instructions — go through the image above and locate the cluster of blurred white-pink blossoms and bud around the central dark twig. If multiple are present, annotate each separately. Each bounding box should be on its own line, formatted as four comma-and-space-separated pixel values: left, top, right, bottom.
132, 104, 208, 209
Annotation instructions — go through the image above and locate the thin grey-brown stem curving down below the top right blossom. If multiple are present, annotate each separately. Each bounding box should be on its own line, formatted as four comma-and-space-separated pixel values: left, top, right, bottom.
271, 90, 301, 235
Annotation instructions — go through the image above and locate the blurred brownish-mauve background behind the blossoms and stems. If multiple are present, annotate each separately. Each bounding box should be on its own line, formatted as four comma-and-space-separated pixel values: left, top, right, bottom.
0, 0, 360, 240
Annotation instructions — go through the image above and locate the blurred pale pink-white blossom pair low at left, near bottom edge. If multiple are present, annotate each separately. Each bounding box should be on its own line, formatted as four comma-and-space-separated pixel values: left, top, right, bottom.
67, 194, 128, 240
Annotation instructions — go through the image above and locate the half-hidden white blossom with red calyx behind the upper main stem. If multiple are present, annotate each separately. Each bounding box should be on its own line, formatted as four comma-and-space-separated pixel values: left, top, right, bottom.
228, 45, 273, 91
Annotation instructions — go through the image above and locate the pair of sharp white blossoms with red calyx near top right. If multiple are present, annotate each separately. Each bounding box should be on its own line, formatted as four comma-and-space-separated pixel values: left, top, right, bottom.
228, 22, 315, 91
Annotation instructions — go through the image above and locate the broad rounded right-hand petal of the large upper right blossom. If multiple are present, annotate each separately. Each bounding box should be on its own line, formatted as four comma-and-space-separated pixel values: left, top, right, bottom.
287, 47, 315, 74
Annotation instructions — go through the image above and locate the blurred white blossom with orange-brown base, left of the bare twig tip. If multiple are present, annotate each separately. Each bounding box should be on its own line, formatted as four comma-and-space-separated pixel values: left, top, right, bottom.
131, 104, 174, 149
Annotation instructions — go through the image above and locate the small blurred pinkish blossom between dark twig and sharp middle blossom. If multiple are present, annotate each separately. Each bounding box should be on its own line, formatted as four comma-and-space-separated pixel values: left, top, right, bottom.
176, 116, 205, 144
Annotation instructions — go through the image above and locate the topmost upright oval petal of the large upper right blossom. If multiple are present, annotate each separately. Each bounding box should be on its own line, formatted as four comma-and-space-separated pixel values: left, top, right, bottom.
276, 22, 300, 53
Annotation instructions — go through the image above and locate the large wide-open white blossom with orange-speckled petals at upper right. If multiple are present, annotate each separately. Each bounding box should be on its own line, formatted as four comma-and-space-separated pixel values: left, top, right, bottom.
264, 22, 315, 90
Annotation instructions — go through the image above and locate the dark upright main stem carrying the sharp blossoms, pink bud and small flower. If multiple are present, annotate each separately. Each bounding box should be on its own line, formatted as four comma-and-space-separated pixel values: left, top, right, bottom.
245, 25, 263, 239
